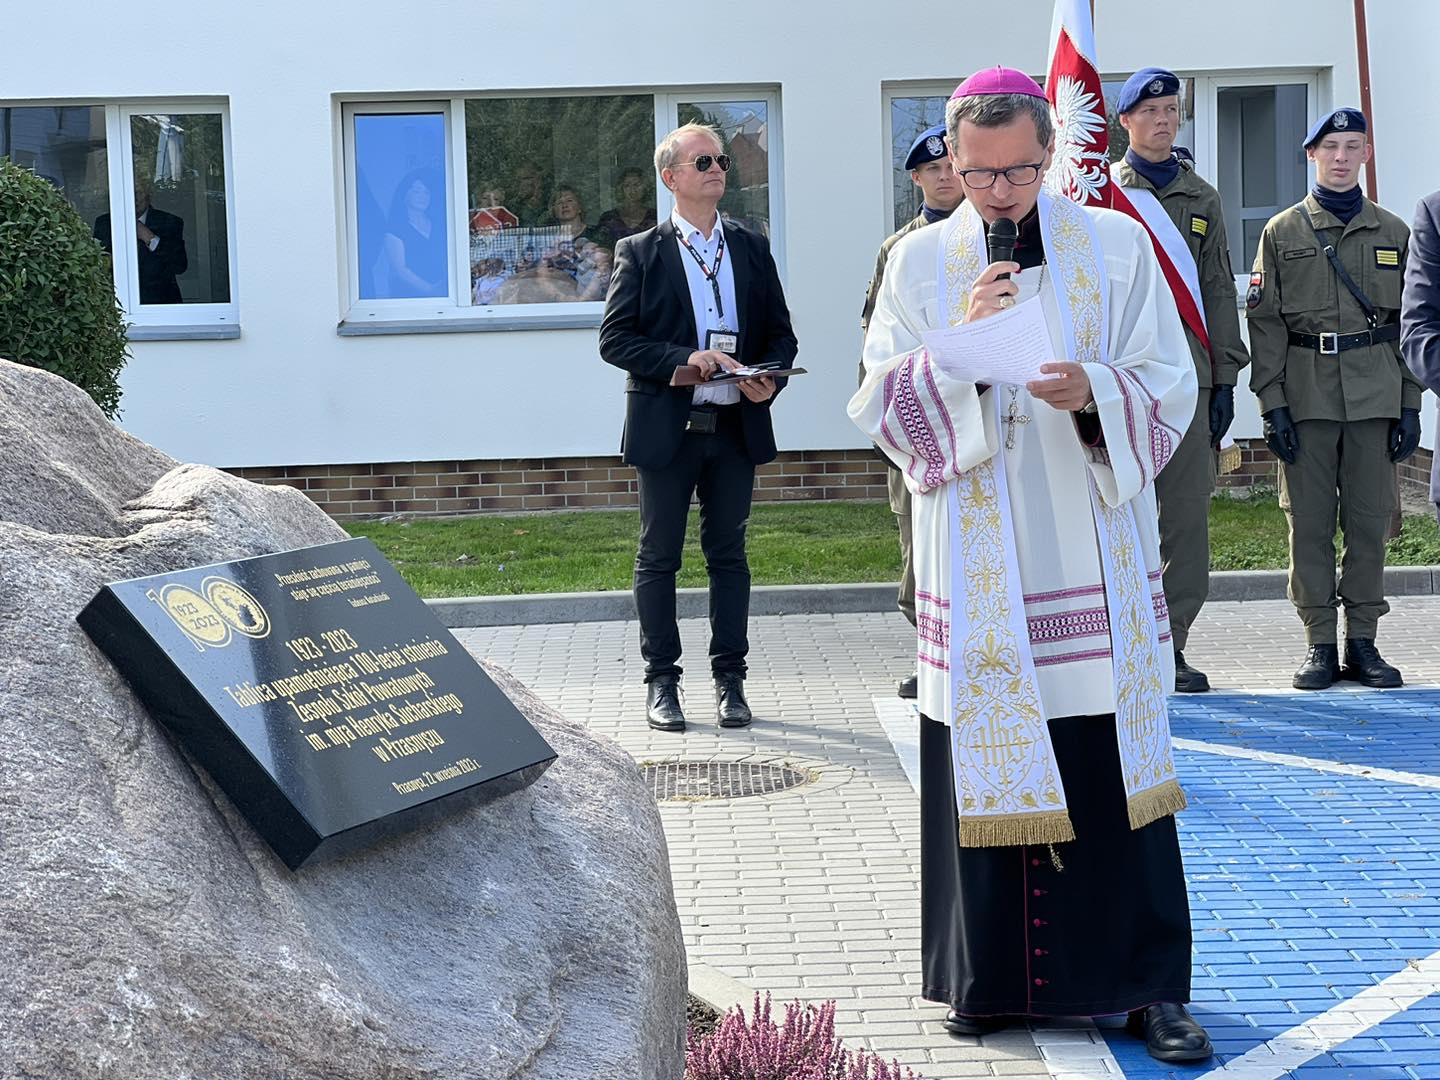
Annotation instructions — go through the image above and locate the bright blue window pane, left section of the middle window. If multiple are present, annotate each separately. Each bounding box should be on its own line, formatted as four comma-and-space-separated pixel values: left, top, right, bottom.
354, 112, 451, 300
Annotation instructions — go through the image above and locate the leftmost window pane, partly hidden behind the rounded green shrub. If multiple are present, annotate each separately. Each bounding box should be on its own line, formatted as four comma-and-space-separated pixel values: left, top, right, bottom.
0, 105, 109, 247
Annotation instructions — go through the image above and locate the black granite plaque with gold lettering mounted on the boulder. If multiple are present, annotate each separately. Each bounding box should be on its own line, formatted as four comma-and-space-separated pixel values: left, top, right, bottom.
79, 540, 554, 870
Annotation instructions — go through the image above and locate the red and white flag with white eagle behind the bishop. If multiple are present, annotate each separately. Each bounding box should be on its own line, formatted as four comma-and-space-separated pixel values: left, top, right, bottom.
1045, 0, 1210, 353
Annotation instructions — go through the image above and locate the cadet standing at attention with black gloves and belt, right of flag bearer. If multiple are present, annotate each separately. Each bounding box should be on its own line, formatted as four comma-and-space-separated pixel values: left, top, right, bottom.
1246, 108, 1423, 690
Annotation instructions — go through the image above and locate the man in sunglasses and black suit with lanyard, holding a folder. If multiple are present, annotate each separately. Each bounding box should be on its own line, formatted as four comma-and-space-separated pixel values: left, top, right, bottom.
600, 124, 796, 732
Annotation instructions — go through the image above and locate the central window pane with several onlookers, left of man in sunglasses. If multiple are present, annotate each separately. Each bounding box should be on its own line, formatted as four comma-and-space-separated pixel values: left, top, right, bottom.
465, 95, 655, 305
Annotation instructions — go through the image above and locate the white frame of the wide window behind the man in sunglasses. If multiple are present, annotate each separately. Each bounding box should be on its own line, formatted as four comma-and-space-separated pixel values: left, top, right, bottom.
334, 85, 785, 337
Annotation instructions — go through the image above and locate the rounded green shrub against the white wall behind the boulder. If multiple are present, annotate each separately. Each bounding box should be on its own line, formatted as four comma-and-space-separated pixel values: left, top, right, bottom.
0, 158, 128, 419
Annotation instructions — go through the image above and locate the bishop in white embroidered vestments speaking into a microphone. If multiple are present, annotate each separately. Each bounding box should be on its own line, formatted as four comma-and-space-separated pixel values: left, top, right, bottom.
850, 73, 1210, 1060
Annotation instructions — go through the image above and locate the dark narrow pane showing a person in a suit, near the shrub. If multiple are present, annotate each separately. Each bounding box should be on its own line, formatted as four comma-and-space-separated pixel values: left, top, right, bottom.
118, 112, 230, 304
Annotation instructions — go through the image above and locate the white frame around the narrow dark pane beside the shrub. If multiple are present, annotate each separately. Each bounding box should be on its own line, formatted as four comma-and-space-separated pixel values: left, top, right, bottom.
115, 99, 240, 341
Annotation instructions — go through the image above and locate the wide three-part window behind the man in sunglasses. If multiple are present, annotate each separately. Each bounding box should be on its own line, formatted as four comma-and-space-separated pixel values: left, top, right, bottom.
341, 91, 780, 334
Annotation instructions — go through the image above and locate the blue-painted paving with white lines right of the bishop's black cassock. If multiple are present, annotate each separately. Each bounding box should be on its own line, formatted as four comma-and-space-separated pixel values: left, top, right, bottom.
1104, 691, 1440, 1080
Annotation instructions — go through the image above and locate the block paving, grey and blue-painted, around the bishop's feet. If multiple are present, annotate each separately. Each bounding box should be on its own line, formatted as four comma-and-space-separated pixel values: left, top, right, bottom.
458, 596, 1440, 1080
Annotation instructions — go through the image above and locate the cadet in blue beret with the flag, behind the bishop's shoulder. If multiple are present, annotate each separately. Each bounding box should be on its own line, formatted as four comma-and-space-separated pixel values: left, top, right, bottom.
1115, 68, 1250, 694
